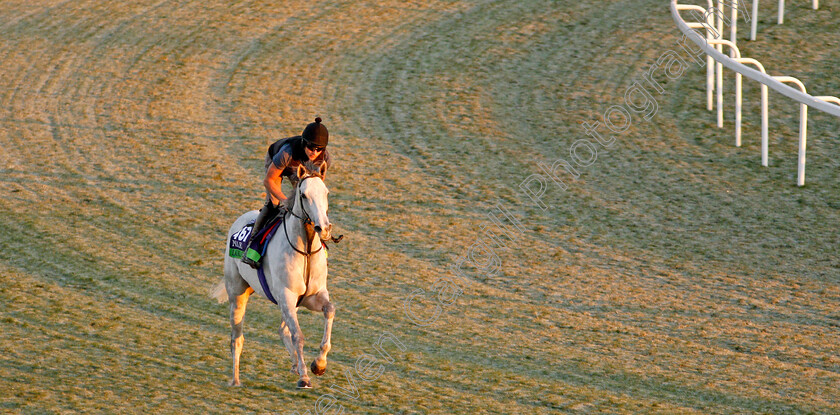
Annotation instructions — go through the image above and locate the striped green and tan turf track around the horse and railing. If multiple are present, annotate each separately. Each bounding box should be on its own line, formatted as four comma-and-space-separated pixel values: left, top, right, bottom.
0, 0, 840, 414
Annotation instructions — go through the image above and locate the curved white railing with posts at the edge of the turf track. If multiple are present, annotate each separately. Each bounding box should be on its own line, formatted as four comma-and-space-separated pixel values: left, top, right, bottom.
671, 0, 840, 186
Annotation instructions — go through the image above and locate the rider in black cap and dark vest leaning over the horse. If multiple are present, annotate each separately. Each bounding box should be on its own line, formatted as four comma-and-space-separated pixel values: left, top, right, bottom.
242, 117, 331, 268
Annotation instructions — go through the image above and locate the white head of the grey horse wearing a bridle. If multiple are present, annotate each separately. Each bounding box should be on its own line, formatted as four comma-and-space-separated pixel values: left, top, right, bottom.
292, 162, 332, 240
